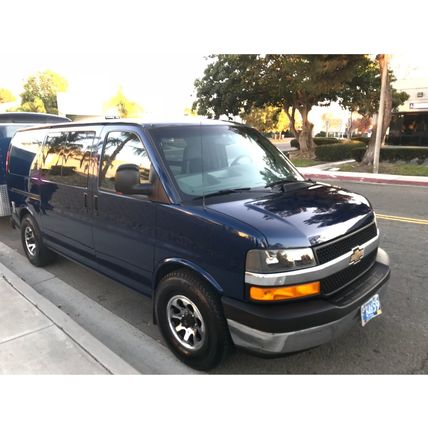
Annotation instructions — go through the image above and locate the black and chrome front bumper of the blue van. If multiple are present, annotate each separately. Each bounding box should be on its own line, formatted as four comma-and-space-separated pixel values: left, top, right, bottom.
222, 248, 390, 355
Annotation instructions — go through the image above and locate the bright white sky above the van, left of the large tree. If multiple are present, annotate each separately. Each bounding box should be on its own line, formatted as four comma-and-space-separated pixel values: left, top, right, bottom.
0, 53, 207, 116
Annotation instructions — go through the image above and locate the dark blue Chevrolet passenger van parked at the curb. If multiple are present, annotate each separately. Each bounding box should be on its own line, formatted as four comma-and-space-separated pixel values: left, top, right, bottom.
8, 119, 390, 370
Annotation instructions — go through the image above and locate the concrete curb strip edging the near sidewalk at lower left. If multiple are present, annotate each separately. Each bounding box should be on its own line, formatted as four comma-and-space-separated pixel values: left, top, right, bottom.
0, 263, 139, 374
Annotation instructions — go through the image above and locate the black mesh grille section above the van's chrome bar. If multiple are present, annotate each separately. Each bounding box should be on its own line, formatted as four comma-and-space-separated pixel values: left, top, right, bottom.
314, 223, 377, 265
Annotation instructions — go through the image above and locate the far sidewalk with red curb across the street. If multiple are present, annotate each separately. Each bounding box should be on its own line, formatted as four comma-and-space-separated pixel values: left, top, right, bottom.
298, 162, 428, 186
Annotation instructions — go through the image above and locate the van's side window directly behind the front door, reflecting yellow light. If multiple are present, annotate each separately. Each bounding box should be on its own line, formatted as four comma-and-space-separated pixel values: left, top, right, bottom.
42, 131, 95, 187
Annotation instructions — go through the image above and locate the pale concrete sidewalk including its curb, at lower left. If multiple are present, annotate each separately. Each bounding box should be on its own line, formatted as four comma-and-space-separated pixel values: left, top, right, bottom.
0, 263, 138, 374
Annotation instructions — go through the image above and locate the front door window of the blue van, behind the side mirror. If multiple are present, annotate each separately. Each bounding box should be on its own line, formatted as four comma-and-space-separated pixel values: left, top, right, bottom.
99, 131, 151, 192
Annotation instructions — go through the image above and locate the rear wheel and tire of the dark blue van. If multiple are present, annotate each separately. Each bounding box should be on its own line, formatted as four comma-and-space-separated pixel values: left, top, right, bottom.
21, 214, 55, 267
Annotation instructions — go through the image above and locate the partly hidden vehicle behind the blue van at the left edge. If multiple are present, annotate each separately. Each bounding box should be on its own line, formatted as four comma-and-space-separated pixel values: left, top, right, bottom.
0, 112, 70, 217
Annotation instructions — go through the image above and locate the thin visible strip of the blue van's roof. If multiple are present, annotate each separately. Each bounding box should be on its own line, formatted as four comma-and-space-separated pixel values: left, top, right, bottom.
12, 117, 243, 132
